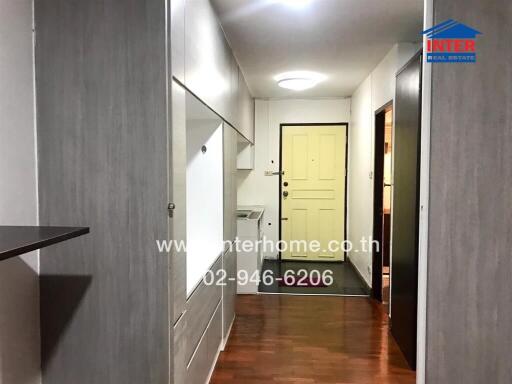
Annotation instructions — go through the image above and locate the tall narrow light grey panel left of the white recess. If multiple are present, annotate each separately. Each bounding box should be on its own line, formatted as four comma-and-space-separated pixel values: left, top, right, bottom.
169, 80, 187, 324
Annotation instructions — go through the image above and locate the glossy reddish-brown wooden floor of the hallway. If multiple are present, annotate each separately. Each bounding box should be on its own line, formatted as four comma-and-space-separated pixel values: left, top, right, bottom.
211, 295, 415, 384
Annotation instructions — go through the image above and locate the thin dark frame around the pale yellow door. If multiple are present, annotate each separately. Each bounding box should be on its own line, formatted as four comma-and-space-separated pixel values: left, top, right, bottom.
278, 122, 349, 261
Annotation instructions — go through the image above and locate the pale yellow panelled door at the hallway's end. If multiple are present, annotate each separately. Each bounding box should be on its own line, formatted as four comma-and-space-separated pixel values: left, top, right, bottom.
280, 124, 348, 261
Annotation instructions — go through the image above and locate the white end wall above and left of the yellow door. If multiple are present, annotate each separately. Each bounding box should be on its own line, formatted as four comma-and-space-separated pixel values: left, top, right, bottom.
238, 98, 351, 258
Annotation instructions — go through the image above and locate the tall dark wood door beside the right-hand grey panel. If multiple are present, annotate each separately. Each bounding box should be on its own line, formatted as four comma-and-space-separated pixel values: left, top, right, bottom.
391, 54, 421, 368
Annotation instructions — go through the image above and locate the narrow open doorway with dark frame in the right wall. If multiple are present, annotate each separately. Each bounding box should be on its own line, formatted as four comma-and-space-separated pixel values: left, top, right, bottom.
372, 101, 393, 314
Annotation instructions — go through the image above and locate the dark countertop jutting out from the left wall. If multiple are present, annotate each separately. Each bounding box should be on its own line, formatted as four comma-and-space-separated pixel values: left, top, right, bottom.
0, 225, 89, 260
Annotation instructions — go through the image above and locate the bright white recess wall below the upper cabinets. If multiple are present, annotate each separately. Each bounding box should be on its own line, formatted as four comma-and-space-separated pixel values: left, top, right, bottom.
187, 120, 224, 294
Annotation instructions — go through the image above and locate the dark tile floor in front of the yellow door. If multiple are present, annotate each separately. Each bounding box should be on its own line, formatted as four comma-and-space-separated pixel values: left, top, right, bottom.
258, 260, 369, 296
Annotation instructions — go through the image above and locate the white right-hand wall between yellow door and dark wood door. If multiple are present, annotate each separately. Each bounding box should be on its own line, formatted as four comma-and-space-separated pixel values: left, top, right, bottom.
348, 43, 419, 286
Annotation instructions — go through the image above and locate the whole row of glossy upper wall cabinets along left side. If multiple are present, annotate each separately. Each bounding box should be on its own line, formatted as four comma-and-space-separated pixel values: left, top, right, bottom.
171, 0, 254, 142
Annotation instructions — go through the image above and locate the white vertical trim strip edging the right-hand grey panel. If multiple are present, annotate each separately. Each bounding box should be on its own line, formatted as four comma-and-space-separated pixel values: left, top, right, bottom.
416, 0, 434, 384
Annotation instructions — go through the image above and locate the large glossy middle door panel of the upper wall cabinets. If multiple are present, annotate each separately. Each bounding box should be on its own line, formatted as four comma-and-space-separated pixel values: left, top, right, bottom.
185, 0, 232, 121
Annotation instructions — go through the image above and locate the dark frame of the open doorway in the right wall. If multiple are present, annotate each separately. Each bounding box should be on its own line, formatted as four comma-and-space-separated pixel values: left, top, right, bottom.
372, 100, 394, 301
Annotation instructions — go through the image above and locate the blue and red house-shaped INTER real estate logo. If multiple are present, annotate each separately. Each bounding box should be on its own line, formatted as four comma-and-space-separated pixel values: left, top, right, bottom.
423, 19, 482, 63
